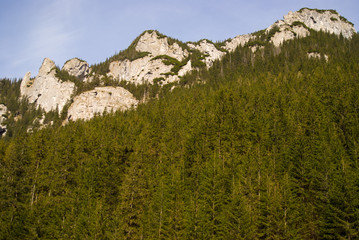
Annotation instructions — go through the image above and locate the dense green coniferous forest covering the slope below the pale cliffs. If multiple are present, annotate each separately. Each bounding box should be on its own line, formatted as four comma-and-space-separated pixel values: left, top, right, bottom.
0, 31, 359, 239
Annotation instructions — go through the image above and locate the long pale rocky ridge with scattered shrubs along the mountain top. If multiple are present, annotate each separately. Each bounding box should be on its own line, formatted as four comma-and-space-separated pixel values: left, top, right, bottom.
20, 8, 356, 124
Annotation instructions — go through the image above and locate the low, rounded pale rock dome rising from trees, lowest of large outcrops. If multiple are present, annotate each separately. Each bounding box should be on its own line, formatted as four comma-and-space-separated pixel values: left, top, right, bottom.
67, 87, 138, 121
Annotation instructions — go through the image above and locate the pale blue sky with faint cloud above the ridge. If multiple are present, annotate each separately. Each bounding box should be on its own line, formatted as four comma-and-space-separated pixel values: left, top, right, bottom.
0, 0, 359, 79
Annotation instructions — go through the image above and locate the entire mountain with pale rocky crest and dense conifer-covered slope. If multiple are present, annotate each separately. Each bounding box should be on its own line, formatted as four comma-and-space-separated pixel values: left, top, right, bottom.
0, 6, 359, 239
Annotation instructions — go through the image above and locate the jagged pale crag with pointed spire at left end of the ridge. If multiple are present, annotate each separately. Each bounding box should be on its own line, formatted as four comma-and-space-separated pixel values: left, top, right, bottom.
20, 58, 75, 113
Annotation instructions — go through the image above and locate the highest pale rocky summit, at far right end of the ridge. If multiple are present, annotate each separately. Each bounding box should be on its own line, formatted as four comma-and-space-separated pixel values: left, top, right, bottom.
266, 8, 356, 46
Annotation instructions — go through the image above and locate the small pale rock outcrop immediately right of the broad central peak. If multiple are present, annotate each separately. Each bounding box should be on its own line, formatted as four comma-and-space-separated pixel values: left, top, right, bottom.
187, 39, 226, 68
